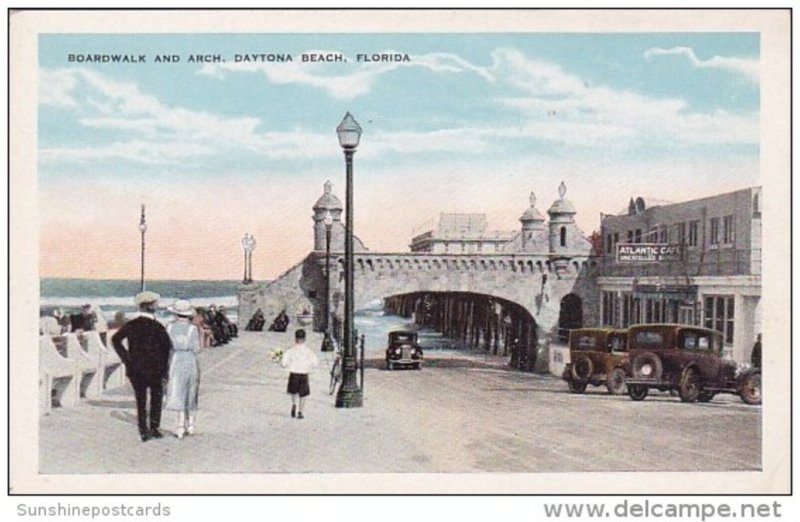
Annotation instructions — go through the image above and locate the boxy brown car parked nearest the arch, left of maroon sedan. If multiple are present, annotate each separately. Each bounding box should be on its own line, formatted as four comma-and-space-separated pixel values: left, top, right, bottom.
561, 328, 629, 395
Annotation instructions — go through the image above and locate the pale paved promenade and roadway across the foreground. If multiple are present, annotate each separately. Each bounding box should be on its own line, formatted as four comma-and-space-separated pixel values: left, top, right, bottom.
39, 332, 761, 484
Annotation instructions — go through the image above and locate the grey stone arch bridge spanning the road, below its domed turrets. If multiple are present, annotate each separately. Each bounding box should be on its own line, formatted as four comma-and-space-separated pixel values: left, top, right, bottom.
234, 252, 598, 367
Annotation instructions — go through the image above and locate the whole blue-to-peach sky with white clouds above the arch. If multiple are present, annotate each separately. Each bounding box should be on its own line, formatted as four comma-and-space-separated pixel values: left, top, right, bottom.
38, 33, 760, 279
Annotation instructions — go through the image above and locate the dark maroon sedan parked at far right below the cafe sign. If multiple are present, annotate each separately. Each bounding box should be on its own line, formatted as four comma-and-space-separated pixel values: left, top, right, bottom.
627, 324, 761, 404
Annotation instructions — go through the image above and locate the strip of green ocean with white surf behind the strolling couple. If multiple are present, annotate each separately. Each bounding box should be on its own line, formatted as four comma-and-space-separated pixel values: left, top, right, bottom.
39, 278, 239, 320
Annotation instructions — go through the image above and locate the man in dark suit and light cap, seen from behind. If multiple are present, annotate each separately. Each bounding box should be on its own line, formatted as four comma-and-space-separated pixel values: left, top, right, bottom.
111, 292, 172, 442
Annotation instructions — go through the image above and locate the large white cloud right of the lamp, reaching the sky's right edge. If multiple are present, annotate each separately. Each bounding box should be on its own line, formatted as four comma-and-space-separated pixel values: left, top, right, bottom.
492, 49, 759, 148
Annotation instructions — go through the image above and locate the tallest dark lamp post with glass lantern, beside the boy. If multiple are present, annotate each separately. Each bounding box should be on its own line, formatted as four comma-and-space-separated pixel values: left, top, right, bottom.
336, 112, 364, 408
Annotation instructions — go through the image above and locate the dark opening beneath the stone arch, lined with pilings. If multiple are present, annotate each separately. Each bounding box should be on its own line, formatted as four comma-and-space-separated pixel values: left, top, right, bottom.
383, 291, 537, 371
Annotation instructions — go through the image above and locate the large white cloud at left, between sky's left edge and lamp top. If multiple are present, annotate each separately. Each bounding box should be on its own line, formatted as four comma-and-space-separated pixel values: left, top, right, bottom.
39, 69, 331, 164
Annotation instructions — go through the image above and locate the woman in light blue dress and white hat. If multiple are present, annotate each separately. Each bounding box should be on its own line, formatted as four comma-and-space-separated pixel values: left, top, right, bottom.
165, 299, 200, 439
